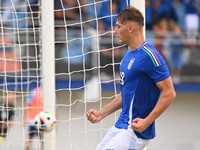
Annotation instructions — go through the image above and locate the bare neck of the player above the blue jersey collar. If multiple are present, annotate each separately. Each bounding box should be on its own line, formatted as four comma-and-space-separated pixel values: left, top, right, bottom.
128, 33, 145, 51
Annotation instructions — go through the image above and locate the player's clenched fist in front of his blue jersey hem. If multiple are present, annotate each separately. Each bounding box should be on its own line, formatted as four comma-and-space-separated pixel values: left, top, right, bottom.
131, 118, 149, 133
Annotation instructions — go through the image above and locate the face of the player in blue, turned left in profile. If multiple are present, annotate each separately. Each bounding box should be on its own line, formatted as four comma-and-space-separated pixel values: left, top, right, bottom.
114, 21, 129, 44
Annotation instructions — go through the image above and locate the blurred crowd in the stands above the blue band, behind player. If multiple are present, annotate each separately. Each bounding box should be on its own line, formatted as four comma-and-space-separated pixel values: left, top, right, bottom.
0, 0, 200, 84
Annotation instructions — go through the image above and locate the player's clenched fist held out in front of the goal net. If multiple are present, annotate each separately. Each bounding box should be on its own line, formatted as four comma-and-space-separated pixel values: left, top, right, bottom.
87, 109, 103, 123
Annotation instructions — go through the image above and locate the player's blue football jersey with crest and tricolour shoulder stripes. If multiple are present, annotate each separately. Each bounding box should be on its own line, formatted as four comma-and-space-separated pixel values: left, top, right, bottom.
115, 42, 170, 139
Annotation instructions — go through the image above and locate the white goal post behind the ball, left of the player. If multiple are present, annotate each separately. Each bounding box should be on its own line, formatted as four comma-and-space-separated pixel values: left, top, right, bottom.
41, 0, 56, 150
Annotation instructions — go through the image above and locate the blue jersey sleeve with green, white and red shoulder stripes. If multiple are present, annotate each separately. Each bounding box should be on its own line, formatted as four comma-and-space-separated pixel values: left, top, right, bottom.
142, 48, 170, 83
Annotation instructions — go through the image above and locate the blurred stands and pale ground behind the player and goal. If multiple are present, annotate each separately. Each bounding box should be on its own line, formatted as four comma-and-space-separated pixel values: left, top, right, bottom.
0, 0, 200, 150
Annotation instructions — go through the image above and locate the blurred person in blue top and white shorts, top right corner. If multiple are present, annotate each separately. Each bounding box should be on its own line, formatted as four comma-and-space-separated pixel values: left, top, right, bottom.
185, 0, 199, 46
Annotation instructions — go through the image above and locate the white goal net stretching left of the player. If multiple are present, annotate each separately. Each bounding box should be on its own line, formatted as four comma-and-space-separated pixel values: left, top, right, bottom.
0, 0, 144, 150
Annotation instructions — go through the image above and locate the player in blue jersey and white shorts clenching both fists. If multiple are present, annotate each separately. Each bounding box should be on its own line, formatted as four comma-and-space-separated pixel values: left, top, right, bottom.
87, 6, 176, 150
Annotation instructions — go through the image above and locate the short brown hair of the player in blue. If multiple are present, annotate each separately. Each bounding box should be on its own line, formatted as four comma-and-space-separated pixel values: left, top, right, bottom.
117, 6, 144, 27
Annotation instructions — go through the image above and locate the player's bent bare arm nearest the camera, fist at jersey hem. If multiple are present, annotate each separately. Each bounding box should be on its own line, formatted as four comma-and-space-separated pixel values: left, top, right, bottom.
131, 77, 176, 133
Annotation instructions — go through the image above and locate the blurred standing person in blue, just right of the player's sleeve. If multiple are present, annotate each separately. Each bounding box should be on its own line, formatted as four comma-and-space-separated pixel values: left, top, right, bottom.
168, 20, 184, 83
